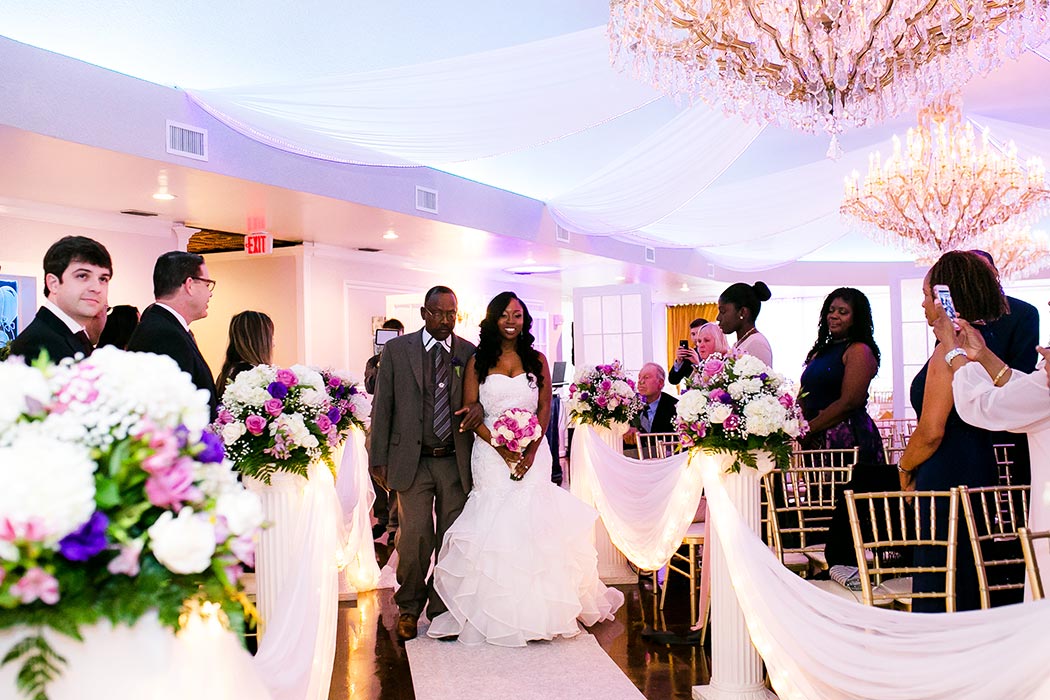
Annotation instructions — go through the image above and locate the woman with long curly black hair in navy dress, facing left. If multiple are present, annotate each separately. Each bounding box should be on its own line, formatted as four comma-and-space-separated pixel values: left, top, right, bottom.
799, 287, 886, 465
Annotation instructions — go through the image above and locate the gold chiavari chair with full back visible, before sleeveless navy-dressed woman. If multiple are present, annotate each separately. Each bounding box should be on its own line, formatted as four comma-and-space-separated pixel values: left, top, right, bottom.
846, 489, 959, 612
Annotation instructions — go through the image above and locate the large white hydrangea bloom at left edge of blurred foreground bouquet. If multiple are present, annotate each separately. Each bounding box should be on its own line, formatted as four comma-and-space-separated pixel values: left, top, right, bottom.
0, 423, 96, 545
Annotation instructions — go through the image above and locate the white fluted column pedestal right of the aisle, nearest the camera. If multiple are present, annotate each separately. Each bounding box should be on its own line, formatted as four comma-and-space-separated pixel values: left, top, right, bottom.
693, 455, 777, 700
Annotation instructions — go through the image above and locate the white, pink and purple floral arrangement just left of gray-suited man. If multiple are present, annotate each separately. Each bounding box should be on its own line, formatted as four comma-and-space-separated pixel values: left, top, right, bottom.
212, 364, 371, 484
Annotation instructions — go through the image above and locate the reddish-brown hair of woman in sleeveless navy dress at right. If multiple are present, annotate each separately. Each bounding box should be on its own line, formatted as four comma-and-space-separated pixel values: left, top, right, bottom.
926, 251, 1010, 323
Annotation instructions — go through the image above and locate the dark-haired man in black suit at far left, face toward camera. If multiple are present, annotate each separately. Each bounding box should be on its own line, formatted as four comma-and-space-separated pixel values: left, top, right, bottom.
11, 236, 113, 362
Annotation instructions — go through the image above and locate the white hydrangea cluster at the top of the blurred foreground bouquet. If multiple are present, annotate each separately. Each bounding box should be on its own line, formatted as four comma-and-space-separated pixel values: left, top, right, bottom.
44, 346, 210, 447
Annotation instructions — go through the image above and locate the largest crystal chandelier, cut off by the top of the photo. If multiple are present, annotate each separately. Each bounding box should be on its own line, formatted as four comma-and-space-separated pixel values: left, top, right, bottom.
609, 0, 1050, 134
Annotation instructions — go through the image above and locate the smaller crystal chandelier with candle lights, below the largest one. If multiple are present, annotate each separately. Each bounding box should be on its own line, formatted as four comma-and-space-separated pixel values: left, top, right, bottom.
839, 96, 1050, 255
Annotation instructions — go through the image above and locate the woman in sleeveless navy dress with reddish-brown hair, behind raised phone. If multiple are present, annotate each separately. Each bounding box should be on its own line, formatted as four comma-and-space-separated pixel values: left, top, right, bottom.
898, 251, 1007, 612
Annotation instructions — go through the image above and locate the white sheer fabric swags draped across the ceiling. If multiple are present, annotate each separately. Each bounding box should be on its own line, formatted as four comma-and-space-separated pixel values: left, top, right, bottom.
190, 26, 1050, 271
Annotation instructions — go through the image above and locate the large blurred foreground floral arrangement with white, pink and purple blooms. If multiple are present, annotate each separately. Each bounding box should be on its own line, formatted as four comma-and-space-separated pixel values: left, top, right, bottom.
0, 347, 263, 699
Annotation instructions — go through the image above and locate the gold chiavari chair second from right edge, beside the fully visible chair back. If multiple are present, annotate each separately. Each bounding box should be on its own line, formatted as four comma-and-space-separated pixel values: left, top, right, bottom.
959, 486, 1029, 608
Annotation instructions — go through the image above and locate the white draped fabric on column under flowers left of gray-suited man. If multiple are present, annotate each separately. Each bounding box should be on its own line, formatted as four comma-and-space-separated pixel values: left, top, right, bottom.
244, 461, 342, 700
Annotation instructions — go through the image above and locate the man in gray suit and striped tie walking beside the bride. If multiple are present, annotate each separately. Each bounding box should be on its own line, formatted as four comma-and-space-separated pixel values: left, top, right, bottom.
369, 287, 484, 639
